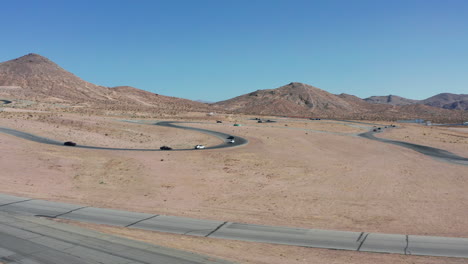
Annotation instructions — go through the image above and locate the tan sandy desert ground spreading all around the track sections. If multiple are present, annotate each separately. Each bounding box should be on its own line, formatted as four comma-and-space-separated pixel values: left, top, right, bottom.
0, 108, 468, 263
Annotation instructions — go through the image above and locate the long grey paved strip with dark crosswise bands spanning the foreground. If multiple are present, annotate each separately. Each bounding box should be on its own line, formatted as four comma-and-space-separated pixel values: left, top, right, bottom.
0, 194, 468, 258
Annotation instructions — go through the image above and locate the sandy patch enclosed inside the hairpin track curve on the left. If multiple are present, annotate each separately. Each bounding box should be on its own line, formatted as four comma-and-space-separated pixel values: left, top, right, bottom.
0, 112, 222, 149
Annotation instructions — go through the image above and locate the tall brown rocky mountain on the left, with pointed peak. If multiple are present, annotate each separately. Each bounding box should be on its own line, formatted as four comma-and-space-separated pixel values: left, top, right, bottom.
0, 53, 207, 111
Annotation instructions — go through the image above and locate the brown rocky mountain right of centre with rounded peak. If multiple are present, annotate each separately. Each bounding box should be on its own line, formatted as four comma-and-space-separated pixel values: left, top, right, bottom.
214, 82, 462, 121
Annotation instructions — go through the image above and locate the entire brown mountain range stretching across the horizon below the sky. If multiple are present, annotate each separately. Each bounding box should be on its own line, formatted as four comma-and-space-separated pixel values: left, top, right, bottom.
0, 53, 468, 121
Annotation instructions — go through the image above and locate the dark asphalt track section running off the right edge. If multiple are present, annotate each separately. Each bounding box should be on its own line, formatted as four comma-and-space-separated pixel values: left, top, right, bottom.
359, 128, 468, 165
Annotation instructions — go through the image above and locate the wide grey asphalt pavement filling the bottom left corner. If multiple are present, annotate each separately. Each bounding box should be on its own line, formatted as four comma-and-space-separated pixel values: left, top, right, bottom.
0, 209, 234, 264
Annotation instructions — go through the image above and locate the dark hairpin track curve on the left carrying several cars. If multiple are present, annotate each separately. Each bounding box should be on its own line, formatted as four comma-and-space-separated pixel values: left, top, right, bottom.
0, 121, 249, 151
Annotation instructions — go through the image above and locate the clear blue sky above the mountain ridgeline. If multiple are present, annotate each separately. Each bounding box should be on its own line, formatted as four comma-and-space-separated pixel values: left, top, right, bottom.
0, 0, 468, 101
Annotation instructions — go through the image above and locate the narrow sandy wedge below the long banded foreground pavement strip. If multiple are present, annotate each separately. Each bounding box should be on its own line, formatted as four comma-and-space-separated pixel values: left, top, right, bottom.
61, 220, 468, 264
